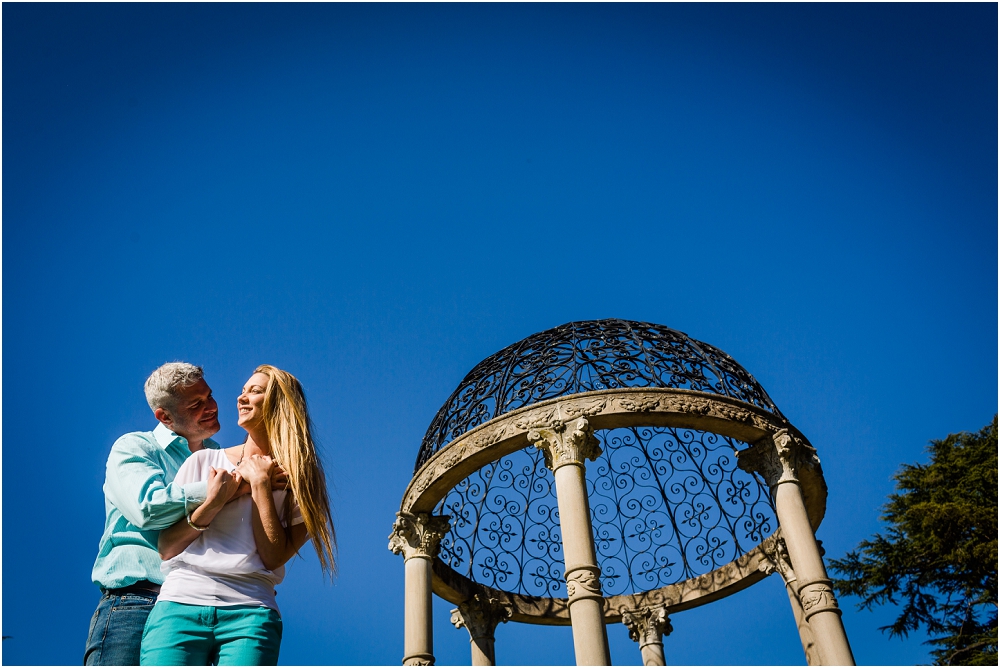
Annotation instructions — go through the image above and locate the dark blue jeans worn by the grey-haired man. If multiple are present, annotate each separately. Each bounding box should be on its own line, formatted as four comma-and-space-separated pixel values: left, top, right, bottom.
83, 592, 156, 666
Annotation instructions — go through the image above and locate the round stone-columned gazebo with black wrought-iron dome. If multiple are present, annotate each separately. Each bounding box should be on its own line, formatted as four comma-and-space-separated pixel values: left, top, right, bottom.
389, 319, 854, 665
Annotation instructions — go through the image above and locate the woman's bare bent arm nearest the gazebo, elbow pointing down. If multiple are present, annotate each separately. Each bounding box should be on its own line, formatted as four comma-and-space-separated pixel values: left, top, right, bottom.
242, 455, 309, 571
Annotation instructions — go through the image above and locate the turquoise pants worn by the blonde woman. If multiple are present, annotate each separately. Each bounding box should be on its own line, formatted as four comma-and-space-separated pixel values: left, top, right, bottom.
139, 601, 281, 666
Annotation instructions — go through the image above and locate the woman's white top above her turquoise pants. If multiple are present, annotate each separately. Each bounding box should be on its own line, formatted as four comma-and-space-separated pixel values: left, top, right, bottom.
159, 449, 303, 610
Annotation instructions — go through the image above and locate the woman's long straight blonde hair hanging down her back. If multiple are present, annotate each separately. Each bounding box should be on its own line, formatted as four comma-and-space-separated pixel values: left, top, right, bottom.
254, 364, 337, 575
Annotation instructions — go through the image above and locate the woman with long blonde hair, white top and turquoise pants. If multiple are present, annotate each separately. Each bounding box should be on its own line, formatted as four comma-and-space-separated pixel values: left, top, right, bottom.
140, 364, 336, 666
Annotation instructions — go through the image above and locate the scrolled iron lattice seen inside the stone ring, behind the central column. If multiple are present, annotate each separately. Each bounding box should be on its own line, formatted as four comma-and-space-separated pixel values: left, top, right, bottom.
435, 427, 777, 597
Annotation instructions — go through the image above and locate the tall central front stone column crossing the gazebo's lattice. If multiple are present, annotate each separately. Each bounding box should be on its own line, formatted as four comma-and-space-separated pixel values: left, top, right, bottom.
528, 418, 611, 666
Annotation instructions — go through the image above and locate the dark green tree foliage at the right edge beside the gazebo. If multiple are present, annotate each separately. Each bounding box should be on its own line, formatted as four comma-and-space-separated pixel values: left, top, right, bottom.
831, 416, 997, 666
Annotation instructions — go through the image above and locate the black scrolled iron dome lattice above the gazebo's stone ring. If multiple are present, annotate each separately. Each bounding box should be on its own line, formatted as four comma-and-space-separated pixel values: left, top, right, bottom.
414, 319, 784, 471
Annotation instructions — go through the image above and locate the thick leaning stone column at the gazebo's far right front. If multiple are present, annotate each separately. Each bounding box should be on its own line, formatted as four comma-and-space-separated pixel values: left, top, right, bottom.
738, 429, 855, 666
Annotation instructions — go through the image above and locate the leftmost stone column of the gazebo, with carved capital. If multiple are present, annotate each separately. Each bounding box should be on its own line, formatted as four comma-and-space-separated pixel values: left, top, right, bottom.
389, 513, 451, 666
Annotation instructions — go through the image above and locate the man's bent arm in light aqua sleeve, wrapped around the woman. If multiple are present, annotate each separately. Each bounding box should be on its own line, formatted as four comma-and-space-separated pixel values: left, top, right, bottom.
104, 434, 208, 531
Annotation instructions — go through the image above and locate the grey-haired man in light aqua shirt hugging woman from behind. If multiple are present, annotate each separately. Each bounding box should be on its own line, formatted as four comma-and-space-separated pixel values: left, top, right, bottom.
84, 362, 234, 666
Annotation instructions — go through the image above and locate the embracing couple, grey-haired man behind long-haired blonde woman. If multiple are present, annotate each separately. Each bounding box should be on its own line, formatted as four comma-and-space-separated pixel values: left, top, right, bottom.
84, 362, 336, 666
